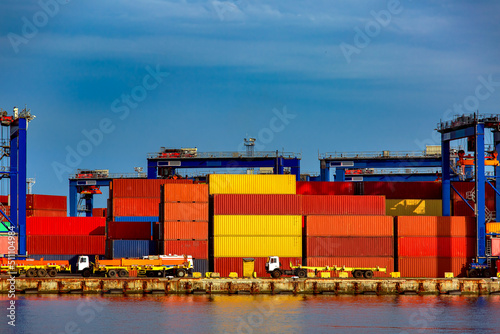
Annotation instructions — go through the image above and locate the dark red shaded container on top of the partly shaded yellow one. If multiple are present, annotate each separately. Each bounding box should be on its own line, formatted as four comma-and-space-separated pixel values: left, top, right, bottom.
363, 181, 443, 199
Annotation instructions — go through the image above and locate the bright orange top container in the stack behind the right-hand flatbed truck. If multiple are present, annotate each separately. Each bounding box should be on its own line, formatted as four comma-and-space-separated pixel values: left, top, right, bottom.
306, 216, 394, 237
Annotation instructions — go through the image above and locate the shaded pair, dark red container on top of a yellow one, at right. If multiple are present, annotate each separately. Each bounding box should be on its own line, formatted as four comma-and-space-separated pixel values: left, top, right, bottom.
363, 182, 443, 216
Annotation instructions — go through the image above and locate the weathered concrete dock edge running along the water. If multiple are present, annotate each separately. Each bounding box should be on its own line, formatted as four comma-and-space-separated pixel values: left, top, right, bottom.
0, 278, 500, 295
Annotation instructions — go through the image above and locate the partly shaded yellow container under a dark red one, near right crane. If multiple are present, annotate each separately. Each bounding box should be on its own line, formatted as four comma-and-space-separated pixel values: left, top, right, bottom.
385, 199, 443, 216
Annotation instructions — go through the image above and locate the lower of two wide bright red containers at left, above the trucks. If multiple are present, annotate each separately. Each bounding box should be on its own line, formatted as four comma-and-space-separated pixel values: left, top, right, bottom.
26, 235, 106, 255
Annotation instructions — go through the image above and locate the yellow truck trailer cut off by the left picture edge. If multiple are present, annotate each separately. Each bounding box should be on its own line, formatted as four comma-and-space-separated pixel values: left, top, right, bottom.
0, 258, 71, 277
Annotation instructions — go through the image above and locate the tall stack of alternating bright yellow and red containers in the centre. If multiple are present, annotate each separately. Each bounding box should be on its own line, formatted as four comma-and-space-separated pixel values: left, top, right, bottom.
209, 175, 302, 277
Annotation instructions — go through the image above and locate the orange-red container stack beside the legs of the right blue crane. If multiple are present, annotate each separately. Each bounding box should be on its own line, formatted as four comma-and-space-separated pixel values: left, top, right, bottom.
396, 217, 476, 277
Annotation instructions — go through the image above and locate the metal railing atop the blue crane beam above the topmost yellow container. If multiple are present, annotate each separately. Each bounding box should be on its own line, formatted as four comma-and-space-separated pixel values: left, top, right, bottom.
147, 151, 302, 159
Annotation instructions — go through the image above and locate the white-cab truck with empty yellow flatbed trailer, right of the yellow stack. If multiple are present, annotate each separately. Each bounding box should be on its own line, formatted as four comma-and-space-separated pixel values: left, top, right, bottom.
266, 256, 387, 279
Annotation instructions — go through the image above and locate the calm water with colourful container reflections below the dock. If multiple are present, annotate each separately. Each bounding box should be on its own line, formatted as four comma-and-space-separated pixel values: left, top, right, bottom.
0, 295, 500, 334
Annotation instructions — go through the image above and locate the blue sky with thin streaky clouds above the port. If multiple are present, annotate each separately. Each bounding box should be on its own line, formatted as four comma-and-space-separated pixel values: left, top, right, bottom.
0, 0, 500, 206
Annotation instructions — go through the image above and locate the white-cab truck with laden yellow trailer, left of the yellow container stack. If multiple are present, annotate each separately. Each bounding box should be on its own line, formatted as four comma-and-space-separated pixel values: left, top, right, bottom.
77, 255, 193, 278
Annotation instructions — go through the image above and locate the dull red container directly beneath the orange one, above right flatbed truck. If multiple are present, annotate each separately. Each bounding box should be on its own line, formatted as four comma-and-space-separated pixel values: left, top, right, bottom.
306, 237, 394, 257
